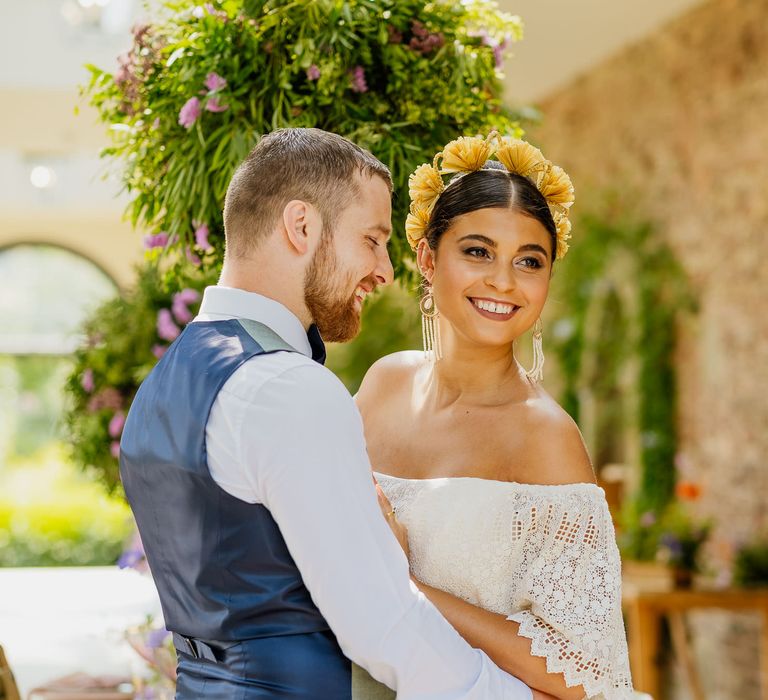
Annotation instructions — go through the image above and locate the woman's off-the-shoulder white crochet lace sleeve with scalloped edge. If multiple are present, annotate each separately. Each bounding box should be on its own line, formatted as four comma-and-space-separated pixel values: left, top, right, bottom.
507, 488, 632, 700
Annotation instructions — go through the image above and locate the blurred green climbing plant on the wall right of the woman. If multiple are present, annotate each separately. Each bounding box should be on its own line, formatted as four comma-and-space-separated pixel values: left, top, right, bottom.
550, 211, 692, 544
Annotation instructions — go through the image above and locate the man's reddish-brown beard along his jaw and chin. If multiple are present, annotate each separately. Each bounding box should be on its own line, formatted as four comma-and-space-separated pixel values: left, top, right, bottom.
304, 230, 360, 343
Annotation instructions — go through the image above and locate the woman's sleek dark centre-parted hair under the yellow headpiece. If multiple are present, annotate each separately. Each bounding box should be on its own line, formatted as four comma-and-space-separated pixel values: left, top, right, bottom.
426, 160, 557, 262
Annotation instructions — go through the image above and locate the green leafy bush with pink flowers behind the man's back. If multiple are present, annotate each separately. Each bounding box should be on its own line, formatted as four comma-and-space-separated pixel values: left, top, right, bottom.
64, 262, 215, 491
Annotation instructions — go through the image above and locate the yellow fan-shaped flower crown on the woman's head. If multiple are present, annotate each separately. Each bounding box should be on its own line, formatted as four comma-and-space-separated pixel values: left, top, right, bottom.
405, 131, 574, 260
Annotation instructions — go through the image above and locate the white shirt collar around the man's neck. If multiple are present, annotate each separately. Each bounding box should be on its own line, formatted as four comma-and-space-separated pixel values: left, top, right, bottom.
195, 286, 313, 357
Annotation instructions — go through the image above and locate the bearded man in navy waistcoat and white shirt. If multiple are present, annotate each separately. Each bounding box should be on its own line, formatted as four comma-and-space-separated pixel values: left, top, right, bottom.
120, 129, 531, 700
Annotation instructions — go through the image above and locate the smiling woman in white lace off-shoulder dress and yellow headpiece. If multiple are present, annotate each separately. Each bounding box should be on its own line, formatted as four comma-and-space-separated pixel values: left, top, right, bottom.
355, 135, 633, 700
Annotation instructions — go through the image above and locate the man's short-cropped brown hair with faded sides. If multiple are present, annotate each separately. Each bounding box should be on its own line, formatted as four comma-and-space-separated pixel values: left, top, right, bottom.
224, 129, 392, 257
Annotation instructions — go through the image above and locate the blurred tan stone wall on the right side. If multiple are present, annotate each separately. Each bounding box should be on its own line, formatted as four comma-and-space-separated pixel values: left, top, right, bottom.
530, 0, 768, 700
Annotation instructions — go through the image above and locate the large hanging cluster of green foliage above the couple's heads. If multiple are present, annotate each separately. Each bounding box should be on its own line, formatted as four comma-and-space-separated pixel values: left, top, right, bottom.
85, 0, 522, 286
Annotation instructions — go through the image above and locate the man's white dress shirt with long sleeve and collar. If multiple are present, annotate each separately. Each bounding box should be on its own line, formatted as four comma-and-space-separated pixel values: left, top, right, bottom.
195, 287, 531, 700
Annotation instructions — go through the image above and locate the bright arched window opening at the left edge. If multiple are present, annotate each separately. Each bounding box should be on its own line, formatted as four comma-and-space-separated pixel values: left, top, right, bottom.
0, 243, 117, 473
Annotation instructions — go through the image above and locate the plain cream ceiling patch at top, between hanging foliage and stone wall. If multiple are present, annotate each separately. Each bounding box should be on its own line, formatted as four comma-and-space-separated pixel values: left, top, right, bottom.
499, 0, 703, 105
